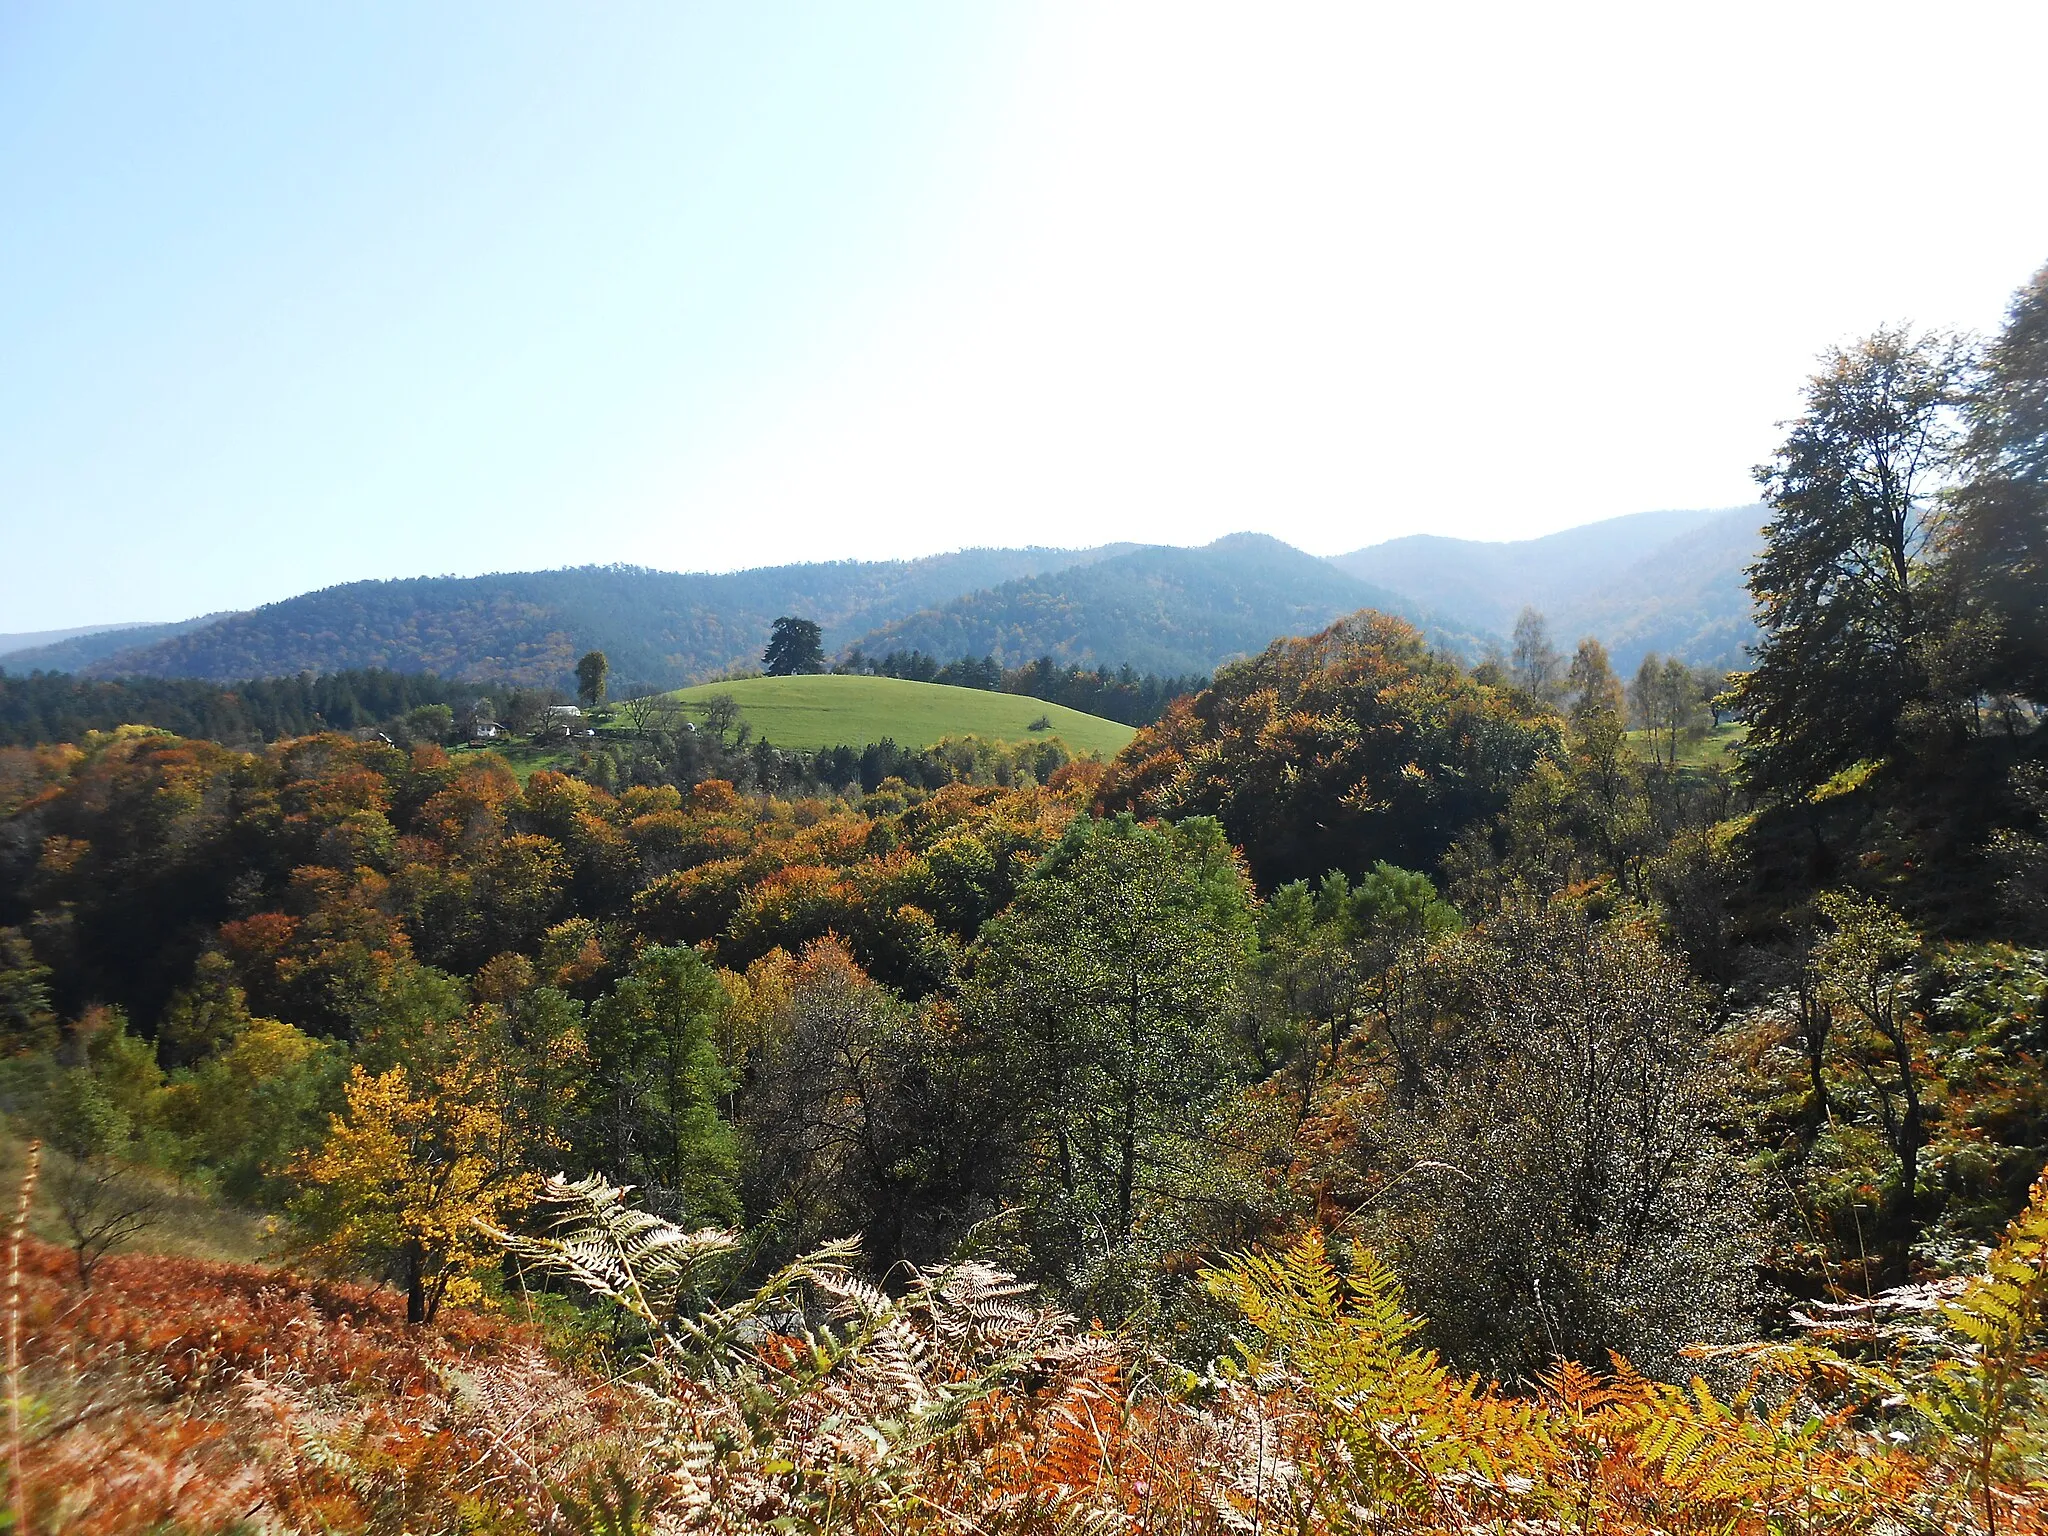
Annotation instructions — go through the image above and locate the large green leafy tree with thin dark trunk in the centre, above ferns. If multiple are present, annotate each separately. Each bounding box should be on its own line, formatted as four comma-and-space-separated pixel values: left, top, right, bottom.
969, 815, 1253, 1284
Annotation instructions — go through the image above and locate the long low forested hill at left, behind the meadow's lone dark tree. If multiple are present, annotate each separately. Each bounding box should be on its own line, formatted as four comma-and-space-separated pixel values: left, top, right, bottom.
88, 545, 1128, 688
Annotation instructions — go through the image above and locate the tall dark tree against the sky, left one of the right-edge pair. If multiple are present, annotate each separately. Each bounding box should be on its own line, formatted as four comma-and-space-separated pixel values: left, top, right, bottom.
1737, 330, 1968, 797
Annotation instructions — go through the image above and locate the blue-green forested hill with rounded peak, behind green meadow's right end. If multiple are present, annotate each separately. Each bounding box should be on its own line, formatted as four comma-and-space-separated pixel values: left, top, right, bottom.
839, 532, 1475, 672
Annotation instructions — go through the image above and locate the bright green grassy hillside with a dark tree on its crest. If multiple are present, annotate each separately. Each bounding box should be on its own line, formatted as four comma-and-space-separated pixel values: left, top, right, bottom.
676, 676, 1137, 758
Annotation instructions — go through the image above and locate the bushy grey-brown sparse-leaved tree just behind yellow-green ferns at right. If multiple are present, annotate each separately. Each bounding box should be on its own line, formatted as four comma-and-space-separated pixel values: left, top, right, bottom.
1343, 905, 1761, 1378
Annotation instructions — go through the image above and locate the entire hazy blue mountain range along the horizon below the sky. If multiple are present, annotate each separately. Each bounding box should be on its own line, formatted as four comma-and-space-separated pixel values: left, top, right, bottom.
16, 506, 1763, 688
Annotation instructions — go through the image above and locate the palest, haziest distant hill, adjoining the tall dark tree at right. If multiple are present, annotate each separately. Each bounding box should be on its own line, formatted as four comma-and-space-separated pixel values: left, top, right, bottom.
1331, 506, 1767, 670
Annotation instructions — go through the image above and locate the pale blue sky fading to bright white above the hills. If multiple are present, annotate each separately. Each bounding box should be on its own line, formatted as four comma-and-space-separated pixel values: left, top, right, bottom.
0, 0, 2048, 631
